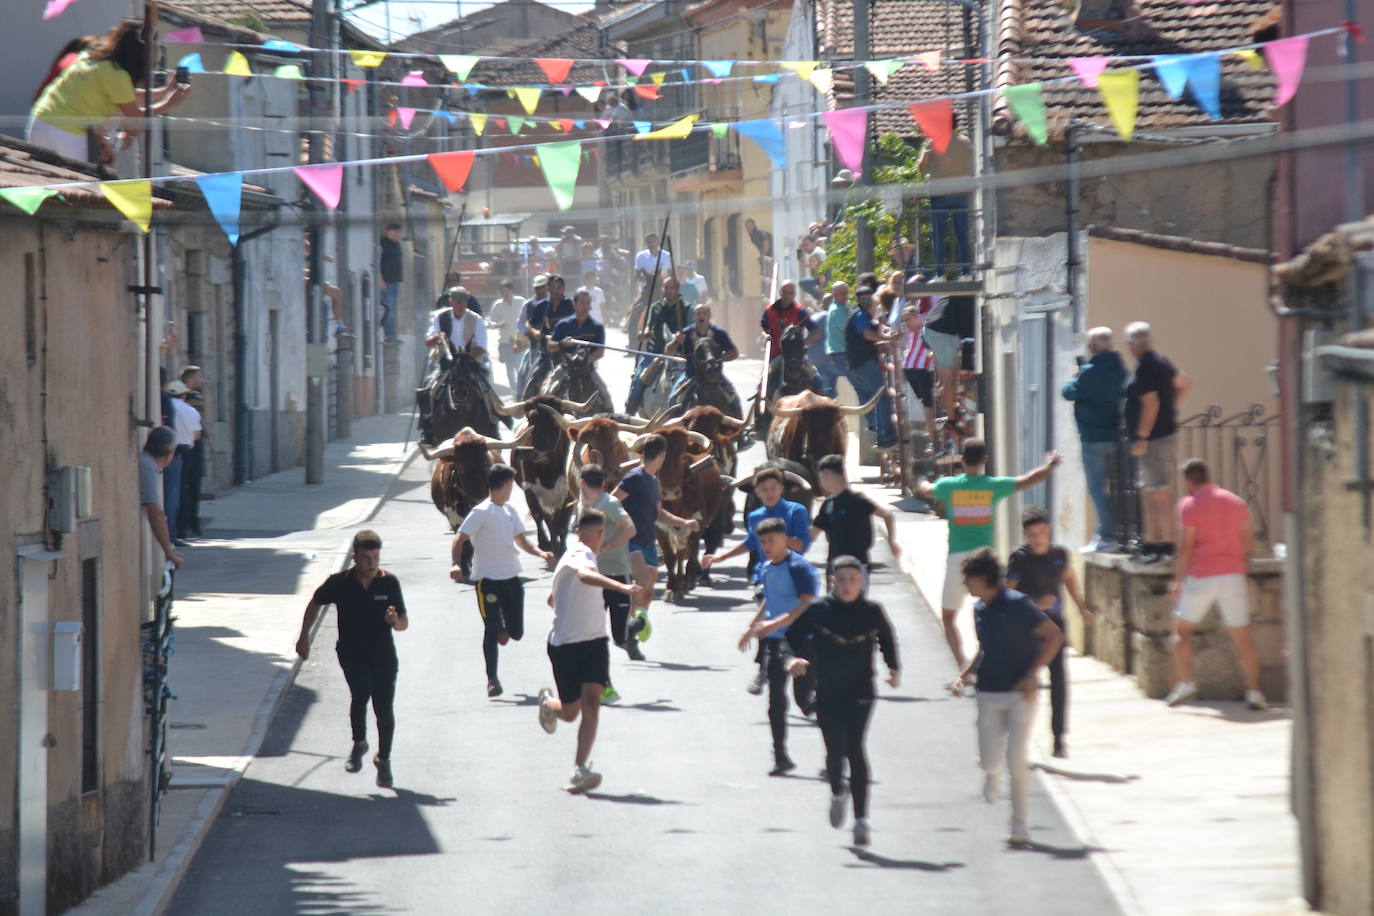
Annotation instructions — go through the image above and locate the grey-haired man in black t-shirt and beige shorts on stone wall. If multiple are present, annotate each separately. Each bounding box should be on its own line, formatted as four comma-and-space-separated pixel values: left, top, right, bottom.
1125, 321, 1191, 563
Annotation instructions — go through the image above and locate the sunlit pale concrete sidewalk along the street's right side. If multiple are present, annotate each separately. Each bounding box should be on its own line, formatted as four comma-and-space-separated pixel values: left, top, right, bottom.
851, 467, 1311, 916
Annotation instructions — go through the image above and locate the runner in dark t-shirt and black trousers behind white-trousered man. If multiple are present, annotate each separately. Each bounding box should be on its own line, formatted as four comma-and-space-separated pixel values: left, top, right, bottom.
1007, 505, 1092, 757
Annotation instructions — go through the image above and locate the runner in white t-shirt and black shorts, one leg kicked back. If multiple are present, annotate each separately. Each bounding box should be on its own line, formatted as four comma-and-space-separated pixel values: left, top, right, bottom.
539, 509, 639, 792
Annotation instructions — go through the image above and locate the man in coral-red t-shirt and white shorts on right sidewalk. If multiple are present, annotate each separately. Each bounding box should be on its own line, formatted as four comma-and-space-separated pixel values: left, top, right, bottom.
1165, 459, 1268, 710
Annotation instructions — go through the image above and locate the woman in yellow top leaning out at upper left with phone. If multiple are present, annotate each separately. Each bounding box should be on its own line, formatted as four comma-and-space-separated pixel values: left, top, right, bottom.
29, 19, 191, 159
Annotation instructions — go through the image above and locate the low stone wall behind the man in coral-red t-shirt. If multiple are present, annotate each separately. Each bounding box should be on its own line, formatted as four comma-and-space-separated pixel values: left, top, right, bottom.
1084, 553, 1287, 700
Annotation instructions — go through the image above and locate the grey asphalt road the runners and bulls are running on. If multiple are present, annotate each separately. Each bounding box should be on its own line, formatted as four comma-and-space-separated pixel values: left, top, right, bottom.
170, 335, 1118, 916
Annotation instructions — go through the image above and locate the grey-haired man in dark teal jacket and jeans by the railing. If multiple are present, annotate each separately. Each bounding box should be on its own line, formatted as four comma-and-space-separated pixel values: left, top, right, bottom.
1063, 328, 1127, 553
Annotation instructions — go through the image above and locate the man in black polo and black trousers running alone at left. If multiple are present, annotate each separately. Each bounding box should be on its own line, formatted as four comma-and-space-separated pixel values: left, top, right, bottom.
295, 531, 409, 788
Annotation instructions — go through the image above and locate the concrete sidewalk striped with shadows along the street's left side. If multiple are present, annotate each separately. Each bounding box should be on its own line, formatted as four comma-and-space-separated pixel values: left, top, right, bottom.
70, 415, 418, 915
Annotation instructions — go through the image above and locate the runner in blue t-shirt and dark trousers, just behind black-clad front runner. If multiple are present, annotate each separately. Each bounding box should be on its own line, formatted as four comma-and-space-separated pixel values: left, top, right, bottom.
739, 518, 820, 776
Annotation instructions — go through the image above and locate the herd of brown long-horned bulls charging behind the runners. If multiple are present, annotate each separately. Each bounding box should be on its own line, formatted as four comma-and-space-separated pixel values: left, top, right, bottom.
420, 391, 877, 600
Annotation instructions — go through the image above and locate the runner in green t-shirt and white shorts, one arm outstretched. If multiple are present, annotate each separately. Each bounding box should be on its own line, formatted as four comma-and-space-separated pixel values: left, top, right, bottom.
916, 439, 1062, 670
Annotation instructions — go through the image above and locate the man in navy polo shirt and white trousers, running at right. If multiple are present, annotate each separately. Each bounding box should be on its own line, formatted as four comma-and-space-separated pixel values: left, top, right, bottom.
949, 549, 1063, 846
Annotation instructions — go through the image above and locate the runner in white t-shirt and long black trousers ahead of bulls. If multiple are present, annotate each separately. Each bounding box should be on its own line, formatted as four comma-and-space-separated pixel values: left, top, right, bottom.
448, 464, 554, 696
